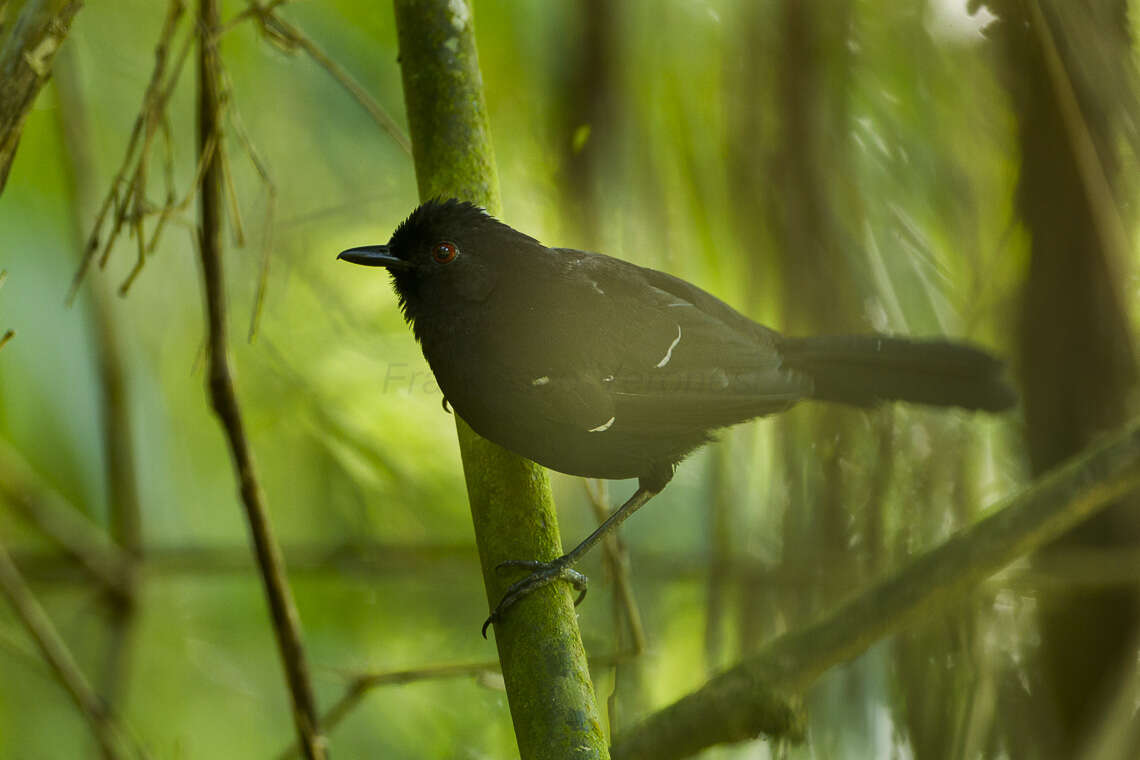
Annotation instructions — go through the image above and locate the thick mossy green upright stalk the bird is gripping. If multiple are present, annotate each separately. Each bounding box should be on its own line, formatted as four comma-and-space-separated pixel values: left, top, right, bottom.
394, 0, 609, 760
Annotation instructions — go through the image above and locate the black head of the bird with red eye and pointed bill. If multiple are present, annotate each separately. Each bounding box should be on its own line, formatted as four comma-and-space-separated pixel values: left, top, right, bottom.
337, 198, 542, 322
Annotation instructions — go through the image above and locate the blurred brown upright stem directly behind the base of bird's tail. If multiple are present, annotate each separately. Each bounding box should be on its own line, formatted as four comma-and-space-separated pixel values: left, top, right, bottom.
751, 0, 857, 626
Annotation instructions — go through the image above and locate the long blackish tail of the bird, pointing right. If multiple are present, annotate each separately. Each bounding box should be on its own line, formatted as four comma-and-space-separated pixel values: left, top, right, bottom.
781, 335, 1017, 411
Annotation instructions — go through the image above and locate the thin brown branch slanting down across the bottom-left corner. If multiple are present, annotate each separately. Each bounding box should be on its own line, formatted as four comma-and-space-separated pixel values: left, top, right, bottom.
0, 542, 125, 760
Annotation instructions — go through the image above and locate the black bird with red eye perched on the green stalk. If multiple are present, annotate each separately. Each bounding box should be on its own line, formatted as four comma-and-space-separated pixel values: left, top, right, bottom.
337, 197, 1017, 637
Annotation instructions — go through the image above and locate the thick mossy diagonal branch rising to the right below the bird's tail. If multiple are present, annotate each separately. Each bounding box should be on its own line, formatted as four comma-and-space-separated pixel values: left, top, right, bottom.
613, 423, 1140, 760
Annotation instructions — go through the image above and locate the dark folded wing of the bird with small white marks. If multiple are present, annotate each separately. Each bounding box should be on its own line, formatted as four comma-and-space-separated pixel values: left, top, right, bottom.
499, 250, 811, 435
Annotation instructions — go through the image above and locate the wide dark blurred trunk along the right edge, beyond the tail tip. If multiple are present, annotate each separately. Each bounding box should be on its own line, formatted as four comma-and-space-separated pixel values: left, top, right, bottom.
986, 0, 1140, 758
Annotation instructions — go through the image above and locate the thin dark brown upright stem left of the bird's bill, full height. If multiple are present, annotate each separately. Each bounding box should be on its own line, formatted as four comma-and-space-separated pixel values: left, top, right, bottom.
198, 0, 325, 760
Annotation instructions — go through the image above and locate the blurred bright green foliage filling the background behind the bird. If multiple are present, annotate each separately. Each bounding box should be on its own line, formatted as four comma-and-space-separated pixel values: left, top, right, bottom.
0, 0, 1130, 758
